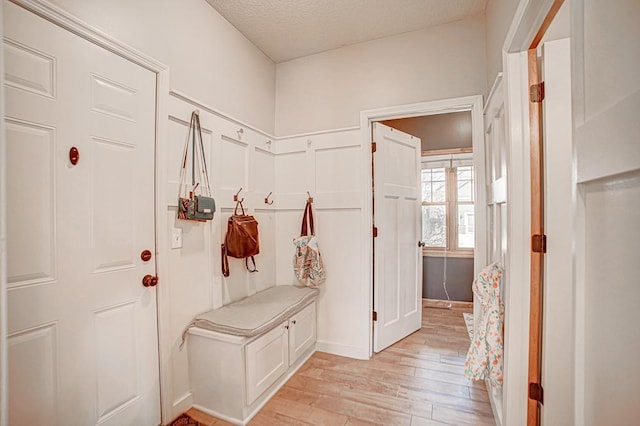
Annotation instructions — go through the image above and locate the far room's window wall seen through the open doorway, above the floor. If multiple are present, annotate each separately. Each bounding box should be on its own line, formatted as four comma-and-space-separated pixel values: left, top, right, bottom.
382, 111, 475, 308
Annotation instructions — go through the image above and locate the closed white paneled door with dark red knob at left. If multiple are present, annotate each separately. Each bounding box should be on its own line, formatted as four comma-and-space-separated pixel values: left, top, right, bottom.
4, 1, 160, 425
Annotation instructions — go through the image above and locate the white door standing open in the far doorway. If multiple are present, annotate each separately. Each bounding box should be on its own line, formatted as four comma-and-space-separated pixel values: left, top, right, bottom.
373, 123, 422, 352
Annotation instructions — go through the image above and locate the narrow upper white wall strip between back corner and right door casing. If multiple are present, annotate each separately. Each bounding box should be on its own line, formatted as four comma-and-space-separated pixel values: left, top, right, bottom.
485, 0, 520, 87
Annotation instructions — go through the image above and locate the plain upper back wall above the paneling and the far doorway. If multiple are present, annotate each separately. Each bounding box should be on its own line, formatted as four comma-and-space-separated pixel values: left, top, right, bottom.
275, 15, 487, 136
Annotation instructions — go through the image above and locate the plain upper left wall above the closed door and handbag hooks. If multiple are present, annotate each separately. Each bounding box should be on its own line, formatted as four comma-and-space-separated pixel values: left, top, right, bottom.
45, 0, 275, 133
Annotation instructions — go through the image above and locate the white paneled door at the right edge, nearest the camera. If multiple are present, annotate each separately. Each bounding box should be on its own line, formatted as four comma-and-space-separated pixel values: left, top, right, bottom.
571, 0, 640, 426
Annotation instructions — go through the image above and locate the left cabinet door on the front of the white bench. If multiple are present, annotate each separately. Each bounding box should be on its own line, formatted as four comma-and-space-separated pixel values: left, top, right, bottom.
246, 323, 289, 405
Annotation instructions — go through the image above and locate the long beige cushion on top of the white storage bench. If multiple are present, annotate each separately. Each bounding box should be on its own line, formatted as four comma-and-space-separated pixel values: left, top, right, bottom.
185, 285, 319, 337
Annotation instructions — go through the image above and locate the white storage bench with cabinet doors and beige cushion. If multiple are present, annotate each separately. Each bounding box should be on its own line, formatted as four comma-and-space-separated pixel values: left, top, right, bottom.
186, 285, 318, 425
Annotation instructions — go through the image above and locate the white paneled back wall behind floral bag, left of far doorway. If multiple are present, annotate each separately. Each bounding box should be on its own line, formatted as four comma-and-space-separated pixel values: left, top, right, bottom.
275, 129, 370, 358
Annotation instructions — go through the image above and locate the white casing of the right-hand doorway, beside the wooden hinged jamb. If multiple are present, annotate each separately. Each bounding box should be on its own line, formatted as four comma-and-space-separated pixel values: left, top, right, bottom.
502, 0, 562, 424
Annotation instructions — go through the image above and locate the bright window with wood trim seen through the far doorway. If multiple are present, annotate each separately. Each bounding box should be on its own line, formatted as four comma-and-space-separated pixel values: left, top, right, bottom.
422, 157, 475, 255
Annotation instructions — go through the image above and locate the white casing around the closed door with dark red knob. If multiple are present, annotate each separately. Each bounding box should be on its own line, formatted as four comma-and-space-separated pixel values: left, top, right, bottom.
0, 0, 171, 426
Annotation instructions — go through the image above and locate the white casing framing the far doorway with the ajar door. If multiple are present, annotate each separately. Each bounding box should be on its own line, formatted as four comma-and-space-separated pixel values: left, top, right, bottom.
360, 95, 487, 357
